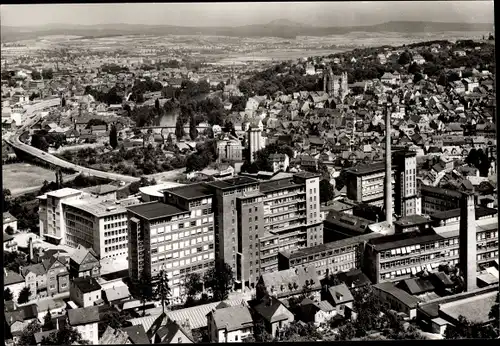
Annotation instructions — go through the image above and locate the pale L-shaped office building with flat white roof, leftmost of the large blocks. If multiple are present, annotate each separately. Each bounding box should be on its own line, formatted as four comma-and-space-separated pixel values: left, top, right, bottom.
38, 188, 139, 259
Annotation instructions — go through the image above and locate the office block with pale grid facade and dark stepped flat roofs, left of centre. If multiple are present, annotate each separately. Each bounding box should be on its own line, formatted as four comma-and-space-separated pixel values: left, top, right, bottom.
128, 184, 215, 299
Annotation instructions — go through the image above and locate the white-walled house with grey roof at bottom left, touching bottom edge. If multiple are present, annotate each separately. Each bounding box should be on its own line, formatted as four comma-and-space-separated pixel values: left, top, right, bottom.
68, 306, 100, 345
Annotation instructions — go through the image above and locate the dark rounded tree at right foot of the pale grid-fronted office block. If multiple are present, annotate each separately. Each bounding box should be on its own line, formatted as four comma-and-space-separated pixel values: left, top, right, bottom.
203, 259, 234, 301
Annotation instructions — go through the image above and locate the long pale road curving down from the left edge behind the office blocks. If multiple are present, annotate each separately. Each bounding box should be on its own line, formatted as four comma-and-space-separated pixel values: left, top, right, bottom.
4, 111, 140, 187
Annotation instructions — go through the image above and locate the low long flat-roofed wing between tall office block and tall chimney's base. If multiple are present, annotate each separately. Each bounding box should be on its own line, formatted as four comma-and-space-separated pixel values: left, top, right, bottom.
278, 233, 381, 275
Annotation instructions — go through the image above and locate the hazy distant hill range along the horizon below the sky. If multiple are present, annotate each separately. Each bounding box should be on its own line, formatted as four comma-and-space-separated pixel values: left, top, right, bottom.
1, 19, 494, 43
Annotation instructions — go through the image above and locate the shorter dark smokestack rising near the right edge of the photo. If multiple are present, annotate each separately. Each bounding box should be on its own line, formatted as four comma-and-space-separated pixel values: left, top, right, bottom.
459, 192, 477, 292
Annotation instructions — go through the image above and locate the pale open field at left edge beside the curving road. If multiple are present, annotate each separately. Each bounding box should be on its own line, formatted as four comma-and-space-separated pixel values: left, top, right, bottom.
2, 163, 60, 194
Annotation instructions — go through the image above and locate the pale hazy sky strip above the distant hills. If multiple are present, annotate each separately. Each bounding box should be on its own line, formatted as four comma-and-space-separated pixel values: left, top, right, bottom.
0, 0, 494, 26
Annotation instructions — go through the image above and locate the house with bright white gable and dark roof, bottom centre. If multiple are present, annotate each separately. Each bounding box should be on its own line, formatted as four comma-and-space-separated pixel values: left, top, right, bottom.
249, 295, 295, 337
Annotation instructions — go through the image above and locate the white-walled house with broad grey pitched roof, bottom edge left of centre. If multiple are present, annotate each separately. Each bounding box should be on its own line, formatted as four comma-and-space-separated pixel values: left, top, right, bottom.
207, 302, 253, 343
